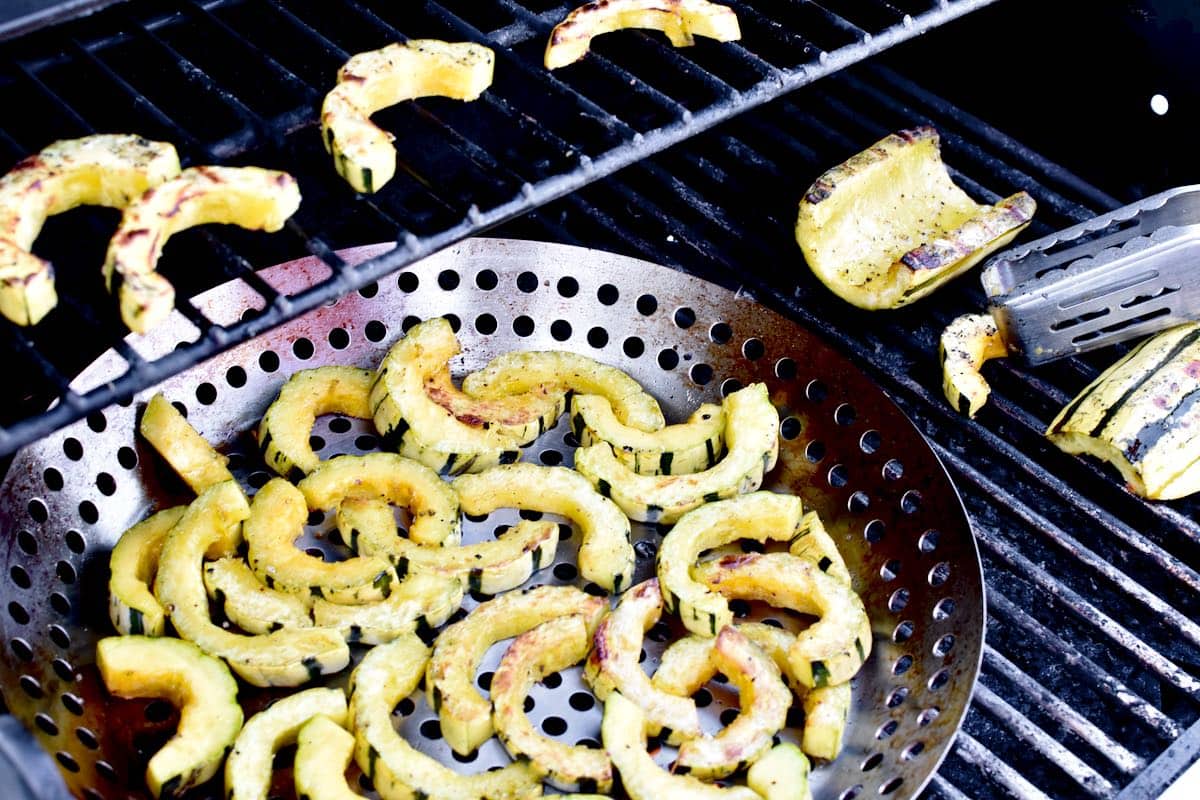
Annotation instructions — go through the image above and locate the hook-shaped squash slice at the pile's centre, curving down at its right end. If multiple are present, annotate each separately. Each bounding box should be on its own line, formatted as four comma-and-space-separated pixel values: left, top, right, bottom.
454, 464, 635, 591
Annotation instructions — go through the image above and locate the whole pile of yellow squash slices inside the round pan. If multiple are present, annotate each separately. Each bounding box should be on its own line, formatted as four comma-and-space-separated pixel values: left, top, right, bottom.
97, 318, 871, 800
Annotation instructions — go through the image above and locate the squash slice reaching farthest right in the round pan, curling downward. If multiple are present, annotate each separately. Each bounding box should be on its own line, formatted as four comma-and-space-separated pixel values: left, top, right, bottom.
692, 553, 871, 688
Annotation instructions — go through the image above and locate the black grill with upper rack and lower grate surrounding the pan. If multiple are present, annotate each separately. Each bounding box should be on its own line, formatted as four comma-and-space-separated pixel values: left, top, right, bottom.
0, 0, 1200, 800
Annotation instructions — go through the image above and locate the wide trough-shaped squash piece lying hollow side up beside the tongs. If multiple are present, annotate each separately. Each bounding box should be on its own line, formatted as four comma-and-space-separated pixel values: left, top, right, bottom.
796, 127, 1037, 308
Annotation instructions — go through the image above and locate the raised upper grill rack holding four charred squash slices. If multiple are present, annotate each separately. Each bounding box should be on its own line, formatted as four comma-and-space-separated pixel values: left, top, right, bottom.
0, 0, 991, 453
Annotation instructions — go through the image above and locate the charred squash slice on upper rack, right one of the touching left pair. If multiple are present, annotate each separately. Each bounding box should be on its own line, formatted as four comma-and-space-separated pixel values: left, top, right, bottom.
104, 167, 300, 333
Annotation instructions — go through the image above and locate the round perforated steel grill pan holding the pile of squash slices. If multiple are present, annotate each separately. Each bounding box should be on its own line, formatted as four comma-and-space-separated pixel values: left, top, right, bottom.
0, 239, 984, 800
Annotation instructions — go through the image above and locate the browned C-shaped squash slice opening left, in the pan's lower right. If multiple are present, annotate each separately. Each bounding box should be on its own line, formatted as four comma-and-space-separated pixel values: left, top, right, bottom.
654, 626, 792, 780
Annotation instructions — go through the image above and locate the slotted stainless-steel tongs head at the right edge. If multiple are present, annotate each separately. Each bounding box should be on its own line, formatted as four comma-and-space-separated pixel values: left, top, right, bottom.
982, 185, 1200, 365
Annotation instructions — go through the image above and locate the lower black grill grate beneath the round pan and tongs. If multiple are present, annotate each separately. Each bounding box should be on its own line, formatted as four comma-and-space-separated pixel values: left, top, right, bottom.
489, 59, 1200, 799
